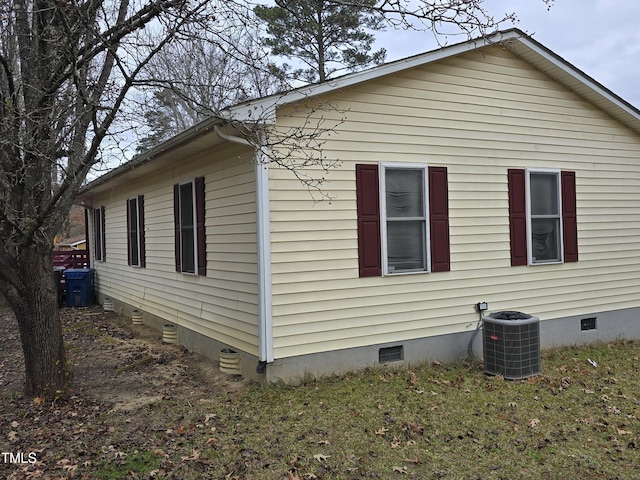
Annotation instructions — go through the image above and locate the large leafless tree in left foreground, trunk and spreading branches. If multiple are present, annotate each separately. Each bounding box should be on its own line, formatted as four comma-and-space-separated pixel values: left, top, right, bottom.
0, 0, 544, 399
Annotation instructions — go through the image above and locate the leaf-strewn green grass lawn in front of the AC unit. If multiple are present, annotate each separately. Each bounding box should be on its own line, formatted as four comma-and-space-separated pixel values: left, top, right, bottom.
193, 343, 640, 479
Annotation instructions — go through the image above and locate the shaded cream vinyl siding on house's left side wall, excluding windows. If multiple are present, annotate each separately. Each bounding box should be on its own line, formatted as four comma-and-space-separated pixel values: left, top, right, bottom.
92, 147, 258, 355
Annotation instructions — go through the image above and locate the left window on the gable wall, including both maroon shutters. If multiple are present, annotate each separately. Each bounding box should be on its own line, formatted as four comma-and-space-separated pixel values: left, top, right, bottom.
356, 163, 450, 277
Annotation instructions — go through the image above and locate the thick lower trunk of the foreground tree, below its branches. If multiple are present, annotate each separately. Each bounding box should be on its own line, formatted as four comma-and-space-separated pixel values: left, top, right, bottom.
7, 246, 72, 399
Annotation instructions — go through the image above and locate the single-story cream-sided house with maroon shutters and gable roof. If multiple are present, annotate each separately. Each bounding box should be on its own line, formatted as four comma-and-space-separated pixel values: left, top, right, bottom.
78, 29, 640, 380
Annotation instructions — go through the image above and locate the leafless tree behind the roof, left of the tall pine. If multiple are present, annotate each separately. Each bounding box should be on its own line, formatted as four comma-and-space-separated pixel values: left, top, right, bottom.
137, 28, 288, 152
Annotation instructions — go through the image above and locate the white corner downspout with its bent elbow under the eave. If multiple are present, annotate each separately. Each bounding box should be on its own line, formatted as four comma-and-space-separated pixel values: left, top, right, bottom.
214, 125, 273, 373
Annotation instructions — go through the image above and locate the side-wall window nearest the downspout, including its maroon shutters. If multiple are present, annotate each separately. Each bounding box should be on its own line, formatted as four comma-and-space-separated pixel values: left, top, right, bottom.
173, 177, 206, 275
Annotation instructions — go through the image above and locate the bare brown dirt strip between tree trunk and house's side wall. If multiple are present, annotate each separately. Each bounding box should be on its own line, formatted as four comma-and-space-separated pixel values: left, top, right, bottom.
0, 306, 246, 411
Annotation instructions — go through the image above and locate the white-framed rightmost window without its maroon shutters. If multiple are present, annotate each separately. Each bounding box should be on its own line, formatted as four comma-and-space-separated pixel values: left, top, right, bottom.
527, 170, 563, 264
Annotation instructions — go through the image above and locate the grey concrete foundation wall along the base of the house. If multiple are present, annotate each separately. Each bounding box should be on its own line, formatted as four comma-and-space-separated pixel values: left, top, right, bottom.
92, 294, 640, 382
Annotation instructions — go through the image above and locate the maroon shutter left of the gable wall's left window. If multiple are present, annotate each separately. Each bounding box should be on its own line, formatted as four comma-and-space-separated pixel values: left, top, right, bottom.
356, 164, 382, 277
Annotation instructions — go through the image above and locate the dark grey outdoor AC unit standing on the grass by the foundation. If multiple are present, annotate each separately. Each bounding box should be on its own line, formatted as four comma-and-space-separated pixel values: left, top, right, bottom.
482, 311, 542, 380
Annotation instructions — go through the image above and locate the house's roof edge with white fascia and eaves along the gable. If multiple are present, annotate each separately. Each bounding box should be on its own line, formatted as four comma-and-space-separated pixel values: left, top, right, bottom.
79, 28, 640, 200
